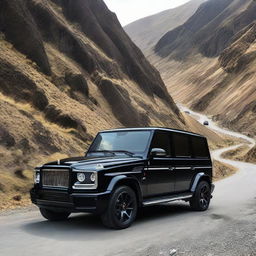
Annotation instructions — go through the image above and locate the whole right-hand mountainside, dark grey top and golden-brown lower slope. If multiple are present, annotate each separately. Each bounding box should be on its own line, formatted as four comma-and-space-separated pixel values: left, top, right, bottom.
151, 0, 256, 138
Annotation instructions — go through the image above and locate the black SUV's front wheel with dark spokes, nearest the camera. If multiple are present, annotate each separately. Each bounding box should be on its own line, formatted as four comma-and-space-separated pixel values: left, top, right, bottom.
101, 186, 138, 229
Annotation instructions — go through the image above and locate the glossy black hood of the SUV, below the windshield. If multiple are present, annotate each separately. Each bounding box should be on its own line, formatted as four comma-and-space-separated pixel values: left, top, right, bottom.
44, 157, 145, 170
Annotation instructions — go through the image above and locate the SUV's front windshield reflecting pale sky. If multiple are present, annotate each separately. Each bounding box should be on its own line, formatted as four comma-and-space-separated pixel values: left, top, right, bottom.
88, 131, 151, 154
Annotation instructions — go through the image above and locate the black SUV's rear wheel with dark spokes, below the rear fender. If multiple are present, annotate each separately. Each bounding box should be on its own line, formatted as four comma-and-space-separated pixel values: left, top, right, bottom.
189, 181, 211, 211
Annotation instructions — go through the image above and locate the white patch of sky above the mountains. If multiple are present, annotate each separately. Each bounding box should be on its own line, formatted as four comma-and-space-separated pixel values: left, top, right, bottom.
104, 0, 189, 26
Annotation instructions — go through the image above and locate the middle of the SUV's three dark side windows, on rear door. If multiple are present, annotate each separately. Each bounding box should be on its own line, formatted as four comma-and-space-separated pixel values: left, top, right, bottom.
172, 133, 191, 157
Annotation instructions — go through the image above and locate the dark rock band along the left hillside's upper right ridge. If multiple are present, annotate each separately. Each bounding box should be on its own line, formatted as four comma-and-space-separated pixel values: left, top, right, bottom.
53, 0, 174, 102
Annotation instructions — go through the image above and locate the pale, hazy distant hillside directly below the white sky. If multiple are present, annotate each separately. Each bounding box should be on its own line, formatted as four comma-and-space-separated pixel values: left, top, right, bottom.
124, 0, 205, 56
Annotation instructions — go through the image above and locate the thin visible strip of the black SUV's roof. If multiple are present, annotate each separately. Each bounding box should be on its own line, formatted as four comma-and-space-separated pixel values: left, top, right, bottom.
101, 127, 205, 138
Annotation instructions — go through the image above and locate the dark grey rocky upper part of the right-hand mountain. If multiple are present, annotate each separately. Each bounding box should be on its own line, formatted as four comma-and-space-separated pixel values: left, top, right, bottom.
155, 0, 256, 60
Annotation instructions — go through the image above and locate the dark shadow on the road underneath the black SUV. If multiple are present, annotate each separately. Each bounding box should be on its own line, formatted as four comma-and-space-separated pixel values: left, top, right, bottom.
21, 203, 191, 241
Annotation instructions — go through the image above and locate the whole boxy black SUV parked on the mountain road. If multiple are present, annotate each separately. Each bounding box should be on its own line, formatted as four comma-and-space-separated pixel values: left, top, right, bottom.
31, 128, 214, 229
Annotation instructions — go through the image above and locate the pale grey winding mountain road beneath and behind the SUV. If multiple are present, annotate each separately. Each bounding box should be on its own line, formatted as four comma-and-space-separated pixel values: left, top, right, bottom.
0, 109, 256, 256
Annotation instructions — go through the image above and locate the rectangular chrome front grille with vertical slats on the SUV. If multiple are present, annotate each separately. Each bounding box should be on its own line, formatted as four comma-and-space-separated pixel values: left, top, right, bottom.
42, 169, 69, 188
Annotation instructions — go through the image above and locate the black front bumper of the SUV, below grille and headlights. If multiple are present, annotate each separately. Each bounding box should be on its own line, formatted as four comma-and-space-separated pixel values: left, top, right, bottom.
30, 188, 111, 214
